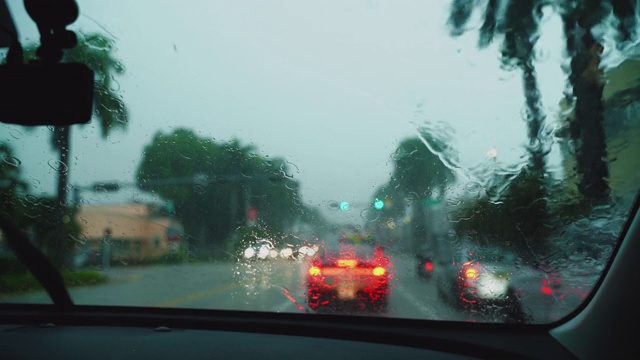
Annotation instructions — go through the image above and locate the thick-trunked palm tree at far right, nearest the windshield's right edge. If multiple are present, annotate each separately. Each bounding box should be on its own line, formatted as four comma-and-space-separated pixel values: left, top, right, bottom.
558, 0, 637, 201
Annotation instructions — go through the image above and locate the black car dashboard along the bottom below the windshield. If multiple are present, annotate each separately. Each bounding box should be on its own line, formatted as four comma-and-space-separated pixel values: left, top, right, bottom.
0, 306, 573, 359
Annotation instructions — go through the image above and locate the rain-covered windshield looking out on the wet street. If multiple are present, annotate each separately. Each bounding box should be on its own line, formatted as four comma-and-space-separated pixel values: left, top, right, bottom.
0, 0, 640, 323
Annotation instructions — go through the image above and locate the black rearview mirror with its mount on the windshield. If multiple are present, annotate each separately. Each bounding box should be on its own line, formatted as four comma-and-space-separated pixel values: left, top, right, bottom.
0, 0, 94, 126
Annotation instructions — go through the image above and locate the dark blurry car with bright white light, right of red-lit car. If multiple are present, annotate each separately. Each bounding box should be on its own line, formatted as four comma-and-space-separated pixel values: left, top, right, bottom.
435, 247, 557, 322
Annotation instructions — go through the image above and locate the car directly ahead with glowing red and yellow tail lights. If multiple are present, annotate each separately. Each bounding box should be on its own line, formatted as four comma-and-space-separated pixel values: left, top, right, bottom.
306, 235, 391, 312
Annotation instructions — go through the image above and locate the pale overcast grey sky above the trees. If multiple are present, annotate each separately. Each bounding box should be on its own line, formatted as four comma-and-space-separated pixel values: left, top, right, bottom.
0, 0, 565, 222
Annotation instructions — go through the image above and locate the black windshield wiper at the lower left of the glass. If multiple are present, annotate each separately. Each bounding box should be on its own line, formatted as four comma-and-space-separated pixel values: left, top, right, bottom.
0, 216, 73, 308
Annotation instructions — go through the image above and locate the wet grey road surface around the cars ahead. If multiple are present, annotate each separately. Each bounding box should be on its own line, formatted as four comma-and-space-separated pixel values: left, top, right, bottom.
0, 256, 490, 321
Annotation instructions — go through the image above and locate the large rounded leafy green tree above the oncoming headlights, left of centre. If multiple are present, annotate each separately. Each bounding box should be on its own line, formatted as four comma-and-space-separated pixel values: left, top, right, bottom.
137, 129, 315, 251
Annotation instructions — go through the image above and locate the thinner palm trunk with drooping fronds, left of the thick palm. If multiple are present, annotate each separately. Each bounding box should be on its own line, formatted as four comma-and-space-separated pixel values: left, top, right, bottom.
449, 0, 550, 256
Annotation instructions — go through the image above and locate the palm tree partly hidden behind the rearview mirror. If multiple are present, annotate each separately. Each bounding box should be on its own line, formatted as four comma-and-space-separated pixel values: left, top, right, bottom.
25, 33, 128, 265
